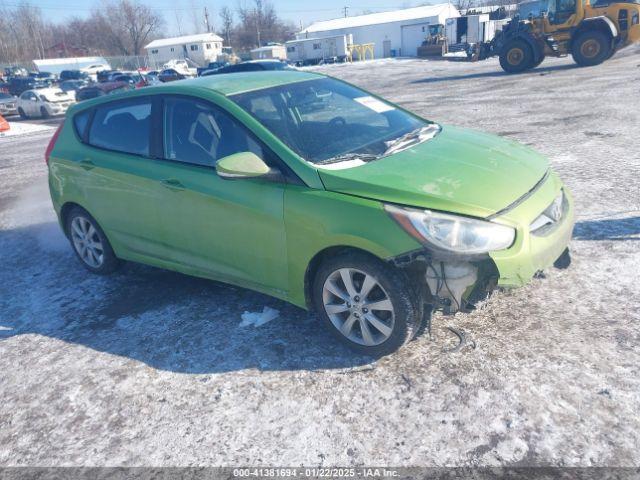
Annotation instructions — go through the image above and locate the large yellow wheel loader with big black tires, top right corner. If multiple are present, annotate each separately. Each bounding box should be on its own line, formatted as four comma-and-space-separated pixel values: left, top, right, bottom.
490, 0, 640, 73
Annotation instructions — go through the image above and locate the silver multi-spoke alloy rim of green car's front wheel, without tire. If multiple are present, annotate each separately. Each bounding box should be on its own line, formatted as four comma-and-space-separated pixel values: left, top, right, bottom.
322, 268, 395, 347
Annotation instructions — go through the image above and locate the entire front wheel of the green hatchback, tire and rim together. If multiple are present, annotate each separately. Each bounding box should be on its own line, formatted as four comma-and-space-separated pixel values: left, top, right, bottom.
313, 252, 422, 357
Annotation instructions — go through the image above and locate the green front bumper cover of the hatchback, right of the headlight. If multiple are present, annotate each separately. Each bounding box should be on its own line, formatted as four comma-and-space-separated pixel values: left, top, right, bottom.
489, 177, 574, 287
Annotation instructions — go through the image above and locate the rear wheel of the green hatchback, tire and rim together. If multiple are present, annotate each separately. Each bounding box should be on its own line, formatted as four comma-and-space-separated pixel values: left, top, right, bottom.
65, 207, 120, 275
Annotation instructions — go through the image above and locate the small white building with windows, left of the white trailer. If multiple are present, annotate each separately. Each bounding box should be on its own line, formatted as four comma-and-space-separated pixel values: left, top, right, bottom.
144, 33, 222, 66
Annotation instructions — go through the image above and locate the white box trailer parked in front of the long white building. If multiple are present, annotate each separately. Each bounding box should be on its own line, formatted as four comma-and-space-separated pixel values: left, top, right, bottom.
285, 33, 353, 67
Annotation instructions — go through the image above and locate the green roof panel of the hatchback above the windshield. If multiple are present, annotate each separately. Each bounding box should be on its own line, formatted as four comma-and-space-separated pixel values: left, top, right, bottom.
172, 70, 325, 96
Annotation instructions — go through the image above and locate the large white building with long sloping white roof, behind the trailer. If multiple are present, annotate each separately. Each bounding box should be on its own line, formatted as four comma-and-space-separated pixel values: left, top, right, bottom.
296, 3, 460, 58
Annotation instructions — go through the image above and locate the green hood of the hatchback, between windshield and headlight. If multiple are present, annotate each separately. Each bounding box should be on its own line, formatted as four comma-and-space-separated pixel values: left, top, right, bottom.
318, 125, 549, 217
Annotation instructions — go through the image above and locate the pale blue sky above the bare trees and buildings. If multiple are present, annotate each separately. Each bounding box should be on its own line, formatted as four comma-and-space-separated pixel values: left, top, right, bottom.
11, 0, 430, 34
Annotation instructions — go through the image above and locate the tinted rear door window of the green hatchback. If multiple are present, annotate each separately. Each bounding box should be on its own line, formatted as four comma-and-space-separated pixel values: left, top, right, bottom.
89, 99, 151, 156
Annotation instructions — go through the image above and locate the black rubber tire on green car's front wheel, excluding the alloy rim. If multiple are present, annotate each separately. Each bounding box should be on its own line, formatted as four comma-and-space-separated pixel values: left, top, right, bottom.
312, 252, 423, 358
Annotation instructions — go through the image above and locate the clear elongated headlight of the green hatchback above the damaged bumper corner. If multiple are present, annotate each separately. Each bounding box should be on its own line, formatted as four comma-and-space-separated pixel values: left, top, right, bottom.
384, 205, 516, 254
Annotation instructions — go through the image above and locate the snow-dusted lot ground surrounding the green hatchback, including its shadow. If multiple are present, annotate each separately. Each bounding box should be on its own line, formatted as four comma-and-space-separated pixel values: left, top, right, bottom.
0, 50, 640, 466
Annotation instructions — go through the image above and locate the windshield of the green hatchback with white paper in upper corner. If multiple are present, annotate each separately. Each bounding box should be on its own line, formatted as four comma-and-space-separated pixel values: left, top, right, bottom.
231, 78, 439, 165
